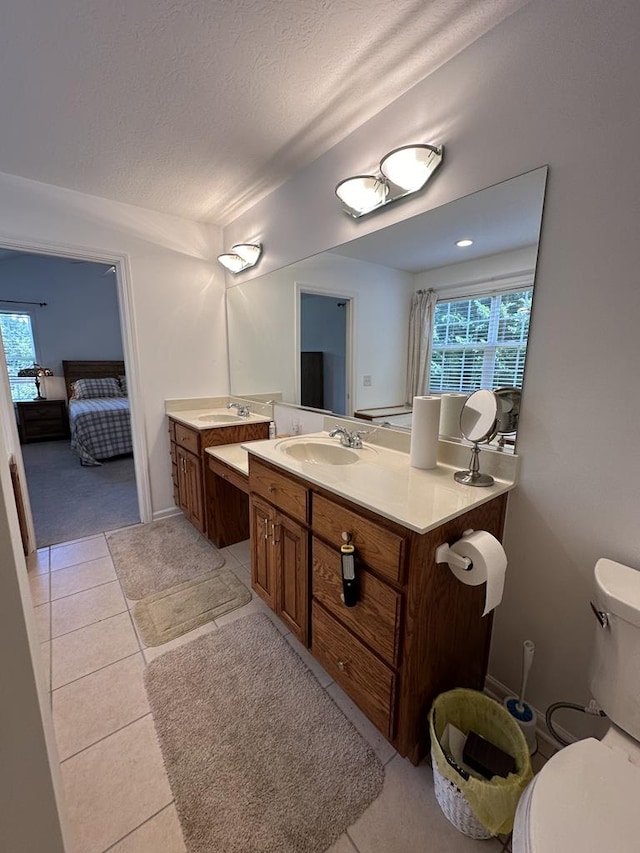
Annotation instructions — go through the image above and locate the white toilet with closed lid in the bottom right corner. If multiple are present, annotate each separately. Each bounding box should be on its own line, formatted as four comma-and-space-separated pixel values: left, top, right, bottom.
512, 560, 640, 853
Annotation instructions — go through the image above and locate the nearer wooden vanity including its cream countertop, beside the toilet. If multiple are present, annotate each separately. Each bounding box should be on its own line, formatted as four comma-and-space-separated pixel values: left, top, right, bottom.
245, 434, 513, 763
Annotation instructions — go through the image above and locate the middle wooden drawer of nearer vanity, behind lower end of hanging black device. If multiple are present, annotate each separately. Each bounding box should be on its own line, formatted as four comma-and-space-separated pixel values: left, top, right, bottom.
312, 538, 402, 666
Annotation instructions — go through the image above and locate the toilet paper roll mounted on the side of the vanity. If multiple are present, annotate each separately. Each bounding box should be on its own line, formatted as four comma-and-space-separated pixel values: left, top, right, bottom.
449, 530, 507, 616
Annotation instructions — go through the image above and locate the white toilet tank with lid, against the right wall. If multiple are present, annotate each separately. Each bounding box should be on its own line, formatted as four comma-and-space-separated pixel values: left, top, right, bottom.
589, 559, 640, 740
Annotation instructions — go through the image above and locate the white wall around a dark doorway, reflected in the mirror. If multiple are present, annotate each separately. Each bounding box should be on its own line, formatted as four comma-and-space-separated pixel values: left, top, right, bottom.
227, 253, 413, 409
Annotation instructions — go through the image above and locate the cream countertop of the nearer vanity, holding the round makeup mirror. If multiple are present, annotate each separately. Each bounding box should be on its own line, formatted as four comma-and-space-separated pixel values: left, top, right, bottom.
240, 432, 515, 533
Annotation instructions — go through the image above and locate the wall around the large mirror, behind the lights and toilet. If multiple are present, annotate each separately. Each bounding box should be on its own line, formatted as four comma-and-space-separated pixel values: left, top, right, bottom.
224, 0, 640, 731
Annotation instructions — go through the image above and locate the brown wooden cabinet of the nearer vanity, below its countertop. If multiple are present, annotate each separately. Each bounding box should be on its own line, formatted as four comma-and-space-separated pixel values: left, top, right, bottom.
249, 454, 507, 764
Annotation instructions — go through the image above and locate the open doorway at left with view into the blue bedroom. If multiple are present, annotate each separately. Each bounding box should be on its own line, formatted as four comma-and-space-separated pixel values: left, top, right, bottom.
0, 249, 142, 548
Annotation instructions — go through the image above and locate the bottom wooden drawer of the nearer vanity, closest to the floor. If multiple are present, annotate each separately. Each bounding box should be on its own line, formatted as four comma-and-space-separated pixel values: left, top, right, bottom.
311, 601, 396, 739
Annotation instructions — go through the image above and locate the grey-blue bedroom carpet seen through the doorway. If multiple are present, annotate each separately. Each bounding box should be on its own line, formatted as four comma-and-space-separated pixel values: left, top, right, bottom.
22, 441, 140, 548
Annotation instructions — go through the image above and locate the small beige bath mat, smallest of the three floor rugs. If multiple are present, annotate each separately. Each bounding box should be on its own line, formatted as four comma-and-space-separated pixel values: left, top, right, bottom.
133, 568, 251, 646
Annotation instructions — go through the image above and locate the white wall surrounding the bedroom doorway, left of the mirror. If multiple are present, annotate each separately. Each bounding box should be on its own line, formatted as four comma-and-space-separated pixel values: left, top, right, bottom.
0, 174, 228, 514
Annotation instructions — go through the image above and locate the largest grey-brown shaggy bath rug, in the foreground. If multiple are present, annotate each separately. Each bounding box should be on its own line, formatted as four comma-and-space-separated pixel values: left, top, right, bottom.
145, 614, 384, 853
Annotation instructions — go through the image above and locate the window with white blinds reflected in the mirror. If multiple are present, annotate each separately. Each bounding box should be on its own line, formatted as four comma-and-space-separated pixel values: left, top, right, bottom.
429, 287, 533, 393
